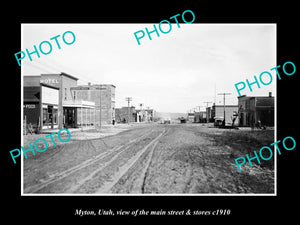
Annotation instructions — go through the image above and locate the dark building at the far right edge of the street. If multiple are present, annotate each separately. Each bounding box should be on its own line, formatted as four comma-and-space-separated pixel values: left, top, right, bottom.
238, 92, 274, 126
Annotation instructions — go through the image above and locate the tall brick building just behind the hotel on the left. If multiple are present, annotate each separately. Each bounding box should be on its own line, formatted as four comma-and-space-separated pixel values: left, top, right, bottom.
71, 83, 116, 125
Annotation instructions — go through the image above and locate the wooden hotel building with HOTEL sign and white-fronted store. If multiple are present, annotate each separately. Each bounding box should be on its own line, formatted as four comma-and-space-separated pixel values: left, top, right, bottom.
23, 73, 95, 130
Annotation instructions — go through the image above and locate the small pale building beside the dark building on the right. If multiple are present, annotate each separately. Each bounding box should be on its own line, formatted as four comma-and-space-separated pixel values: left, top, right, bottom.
211, 104, 238, 125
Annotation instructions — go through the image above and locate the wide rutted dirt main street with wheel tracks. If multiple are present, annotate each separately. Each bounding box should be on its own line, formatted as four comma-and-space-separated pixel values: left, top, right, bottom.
23, 124, 274, 194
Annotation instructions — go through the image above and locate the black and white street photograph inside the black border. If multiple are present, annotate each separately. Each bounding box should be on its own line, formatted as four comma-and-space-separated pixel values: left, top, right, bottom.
20, 23, 276, 195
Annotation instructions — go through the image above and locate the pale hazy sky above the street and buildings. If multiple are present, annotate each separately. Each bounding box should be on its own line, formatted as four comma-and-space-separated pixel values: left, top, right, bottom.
20, 22, 277, 113
